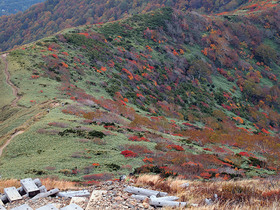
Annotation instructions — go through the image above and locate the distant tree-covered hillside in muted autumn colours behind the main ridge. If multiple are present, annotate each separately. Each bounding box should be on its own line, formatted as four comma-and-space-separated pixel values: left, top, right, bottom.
0, 0, 256, 51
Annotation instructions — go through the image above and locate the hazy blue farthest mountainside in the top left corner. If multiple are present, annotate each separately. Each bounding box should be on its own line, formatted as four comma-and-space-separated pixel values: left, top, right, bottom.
0, 0, 44, 16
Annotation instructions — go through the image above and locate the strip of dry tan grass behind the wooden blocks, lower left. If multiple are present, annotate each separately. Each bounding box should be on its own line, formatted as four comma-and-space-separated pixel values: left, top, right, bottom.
0, 178, 78, 193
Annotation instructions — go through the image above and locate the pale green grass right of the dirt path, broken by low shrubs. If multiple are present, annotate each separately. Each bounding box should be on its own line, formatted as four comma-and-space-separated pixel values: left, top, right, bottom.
0, 102, 151, 180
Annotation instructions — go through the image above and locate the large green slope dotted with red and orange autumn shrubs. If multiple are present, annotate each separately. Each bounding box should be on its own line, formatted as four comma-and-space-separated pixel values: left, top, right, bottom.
0, 8, 280, 183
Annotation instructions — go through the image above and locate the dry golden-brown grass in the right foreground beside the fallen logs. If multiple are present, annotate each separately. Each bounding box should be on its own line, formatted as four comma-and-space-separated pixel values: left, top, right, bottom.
136, 175, 280, 210
